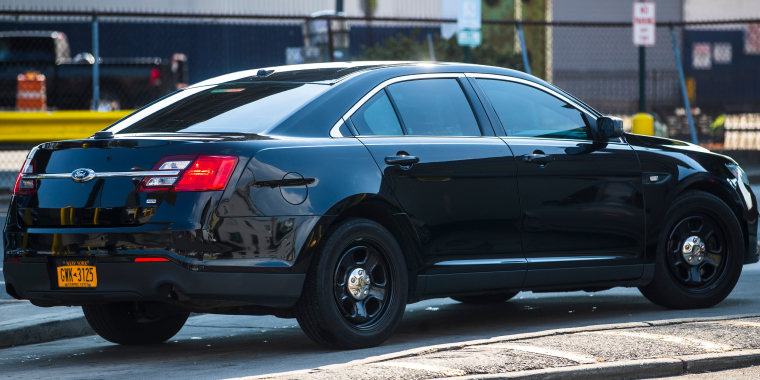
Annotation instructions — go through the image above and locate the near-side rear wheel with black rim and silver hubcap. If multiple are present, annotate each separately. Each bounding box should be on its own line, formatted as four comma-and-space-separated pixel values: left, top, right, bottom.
295, 218, 409, 349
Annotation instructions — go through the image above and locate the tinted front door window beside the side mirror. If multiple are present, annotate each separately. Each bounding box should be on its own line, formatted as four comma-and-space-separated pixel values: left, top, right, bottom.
478, 79, 590, 140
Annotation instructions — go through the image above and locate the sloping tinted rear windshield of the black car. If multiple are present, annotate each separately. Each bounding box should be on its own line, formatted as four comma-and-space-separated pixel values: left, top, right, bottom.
107, 83, 330, 133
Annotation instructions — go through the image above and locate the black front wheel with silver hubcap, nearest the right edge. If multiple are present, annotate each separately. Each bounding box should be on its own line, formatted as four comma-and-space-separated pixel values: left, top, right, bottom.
639, 191, 744, 309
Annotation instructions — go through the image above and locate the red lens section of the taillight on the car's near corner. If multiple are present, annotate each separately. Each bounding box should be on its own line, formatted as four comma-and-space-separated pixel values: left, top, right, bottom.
171, 156, 238, 192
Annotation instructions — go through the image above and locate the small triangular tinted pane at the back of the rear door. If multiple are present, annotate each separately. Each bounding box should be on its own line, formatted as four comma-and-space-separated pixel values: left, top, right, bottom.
351, 90, 404, 136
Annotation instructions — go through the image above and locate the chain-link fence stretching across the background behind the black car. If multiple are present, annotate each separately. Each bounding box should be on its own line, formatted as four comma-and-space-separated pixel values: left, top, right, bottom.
0, 11, 760, 195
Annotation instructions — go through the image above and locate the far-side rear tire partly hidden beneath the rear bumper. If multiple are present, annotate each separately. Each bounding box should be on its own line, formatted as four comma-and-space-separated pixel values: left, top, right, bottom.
82, 302, 190, 345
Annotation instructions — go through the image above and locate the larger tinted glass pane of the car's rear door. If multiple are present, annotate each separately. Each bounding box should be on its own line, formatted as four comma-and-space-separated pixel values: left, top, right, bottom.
387, 79, 482, 136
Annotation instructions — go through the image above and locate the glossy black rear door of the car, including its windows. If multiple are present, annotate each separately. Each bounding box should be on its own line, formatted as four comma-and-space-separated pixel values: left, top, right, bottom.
348, 74, 527, 294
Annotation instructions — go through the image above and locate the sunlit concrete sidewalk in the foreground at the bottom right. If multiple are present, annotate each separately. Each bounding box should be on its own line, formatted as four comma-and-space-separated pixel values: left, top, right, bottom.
245, 315, 760, 380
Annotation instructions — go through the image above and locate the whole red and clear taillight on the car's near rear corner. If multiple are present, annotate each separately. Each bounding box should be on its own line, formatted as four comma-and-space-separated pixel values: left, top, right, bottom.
138, 156, 238, 192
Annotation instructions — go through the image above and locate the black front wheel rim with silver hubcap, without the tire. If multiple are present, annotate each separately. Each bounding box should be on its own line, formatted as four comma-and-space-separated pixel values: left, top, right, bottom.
667, 214, 730, 292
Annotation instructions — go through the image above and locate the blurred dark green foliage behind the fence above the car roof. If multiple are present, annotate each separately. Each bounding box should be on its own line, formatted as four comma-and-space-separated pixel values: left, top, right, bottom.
355, 29, 523, 71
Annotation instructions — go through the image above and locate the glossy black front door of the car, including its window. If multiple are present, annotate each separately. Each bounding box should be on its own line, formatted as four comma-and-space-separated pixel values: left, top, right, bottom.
468, 74, 645, 286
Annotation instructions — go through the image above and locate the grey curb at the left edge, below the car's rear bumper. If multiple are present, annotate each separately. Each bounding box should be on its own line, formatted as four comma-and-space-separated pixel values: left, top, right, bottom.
0, 317, 95, 348
